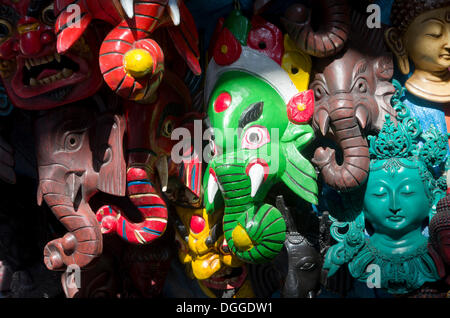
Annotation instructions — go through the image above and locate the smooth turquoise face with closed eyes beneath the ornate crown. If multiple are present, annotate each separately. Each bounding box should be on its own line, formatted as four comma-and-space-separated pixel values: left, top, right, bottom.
363, 159, 431, 246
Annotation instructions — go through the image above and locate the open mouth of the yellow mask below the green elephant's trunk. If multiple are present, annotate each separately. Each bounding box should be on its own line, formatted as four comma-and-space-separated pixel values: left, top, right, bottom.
200, 265, 247, 296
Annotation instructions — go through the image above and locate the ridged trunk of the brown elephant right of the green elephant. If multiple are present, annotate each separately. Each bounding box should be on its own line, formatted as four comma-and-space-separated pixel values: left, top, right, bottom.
313, 99, 370, 191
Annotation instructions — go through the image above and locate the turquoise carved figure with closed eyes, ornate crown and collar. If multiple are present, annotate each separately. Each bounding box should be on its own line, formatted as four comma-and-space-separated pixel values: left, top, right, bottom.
323, 80, 447, 294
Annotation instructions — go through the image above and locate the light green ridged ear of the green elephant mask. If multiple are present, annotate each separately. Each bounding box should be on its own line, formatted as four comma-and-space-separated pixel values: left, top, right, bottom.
281, 123, 319, 204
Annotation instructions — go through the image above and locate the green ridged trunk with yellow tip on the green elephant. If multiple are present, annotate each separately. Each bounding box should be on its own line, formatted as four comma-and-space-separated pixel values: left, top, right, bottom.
207, 162, 286, 263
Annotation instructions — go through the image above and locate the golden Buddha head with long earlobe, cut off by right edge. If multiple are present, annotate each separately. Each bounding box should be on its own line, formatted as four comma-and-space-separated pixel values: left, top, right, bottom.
386, 6, 450, 103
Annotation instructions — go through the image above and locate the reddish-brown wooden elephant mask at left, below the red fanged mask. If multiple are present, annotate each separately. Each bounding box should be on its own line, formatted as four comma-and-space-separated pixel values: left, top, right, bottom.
35, 101, 126, 270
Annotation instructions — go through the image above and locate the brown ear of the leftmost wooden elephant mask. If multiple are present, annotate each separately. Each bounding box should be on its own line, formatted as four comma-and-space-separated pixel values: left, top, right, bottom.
92, 114, 126, 196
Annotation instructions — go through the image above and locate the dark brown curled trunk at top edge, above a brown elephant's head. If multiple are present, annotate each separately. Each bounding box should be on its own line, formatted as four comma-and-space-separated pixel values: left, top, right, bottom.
282, 0, 350, 57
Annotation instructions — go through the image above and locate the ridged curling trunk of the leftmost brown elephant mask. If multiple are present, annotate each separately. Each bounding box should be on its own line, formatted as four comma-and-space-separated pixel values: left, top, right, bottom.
38, 178, 103, 270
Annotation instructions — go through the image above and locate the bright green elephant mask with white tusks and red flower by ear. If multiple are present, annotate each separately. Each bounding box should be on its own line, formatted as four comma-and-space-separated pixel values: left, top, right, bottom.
204, 70, 318, 263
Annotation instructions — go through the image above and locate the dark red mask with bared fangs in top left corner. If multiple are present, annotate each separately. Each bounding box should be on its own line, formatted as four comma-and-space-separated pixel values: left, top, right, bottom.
0, 0, 102, 110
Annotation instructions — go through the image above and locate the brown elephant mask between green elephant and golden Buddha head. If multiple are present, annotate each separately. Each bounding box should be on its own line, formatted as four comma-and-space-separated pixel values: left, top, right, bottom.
310, 13, 395, 191
